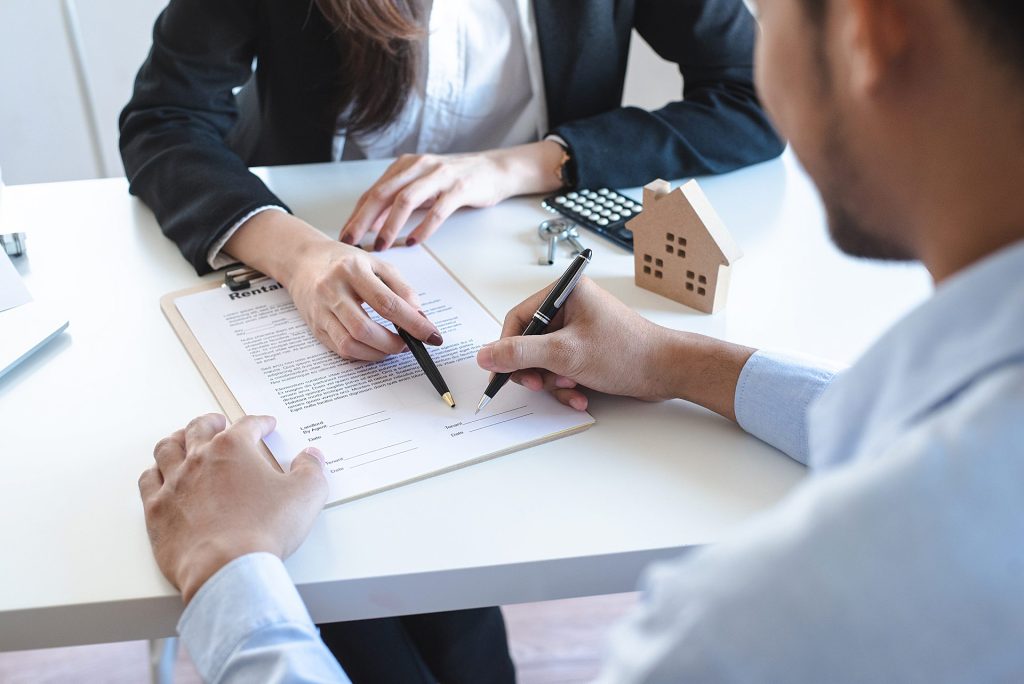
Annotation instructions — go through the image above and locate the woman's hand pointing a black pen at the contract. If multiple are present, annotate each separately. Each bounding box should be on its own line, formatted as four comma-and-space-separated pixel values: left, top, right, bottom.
224, 211, 442, 360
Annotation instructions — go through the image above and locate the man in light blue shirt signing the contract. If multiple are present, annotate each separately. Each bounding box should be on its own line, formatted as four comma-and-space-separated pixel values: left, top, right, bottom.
140, 0, 1024, 682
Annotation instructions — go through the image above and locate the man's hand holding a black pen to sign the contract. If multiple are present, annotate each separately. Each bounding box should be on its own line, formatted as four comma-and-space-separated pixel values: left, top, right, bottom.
476, 277, 754, 420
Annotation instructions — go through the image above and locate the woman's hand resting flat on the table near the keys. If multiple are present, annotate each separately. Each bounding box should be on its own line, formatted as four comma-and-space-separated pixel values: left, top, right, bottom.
340, 140, 562, 252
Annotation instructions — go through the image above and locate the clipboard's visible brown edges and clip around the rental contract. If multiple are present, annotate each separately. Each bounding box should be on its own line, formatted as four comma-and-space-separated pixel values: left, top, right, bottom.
160, 246, 596, 508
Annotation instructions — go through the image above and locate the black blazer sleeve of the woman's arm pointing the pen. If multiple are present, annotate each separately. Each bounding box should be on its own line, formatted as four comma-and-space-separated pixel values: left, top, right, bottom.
120, 0, 287, 274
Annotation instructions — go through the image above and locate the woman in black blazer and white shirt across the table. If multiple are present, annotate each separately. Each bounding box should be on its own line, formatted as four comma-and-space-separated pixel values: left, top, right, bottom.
121, 0, 782, 682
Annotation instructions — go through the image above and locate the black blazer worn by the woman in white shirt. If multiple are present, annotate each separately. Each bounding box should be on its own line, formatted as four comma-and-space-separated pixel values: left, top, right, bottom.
120, 0, 782, 273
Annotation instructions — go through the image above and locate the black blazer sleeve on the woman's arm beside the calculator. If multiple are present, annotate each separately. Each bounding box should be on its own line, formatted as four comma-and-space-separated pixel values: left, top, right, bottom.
553, 0, 784, 187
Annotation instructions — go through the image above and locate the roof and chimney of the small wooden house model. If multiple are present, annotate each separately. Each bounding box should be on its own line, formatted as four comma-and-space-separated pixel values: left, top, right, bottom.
630, 180, 743, 266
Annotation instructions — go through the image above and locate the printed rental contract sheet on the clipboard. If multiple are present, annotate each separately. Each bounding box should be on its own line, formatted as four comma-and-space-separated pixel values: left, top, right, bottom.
174, 248, 594, 505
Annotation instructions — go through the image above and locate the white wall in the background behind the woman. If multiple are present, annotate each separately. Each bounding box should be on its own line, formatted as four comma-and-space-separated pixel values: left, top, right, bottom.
0, 0, 681, 184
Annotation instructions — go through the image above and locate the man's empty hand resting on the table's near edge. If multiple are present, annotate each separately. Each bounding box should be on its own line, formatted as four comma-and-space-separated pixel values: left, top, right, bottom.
138, 414, 328, 603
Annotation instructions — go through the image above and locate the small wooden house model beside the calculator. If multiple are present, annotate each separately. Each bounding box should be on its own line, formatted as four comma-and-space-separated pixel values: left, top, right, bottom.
627, 180, 742, 313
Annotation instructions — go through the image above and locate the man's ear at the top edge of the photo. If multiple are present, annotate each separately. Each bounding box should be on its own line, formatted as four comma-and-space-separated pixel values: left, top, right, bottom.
833, 0, 913, 96
